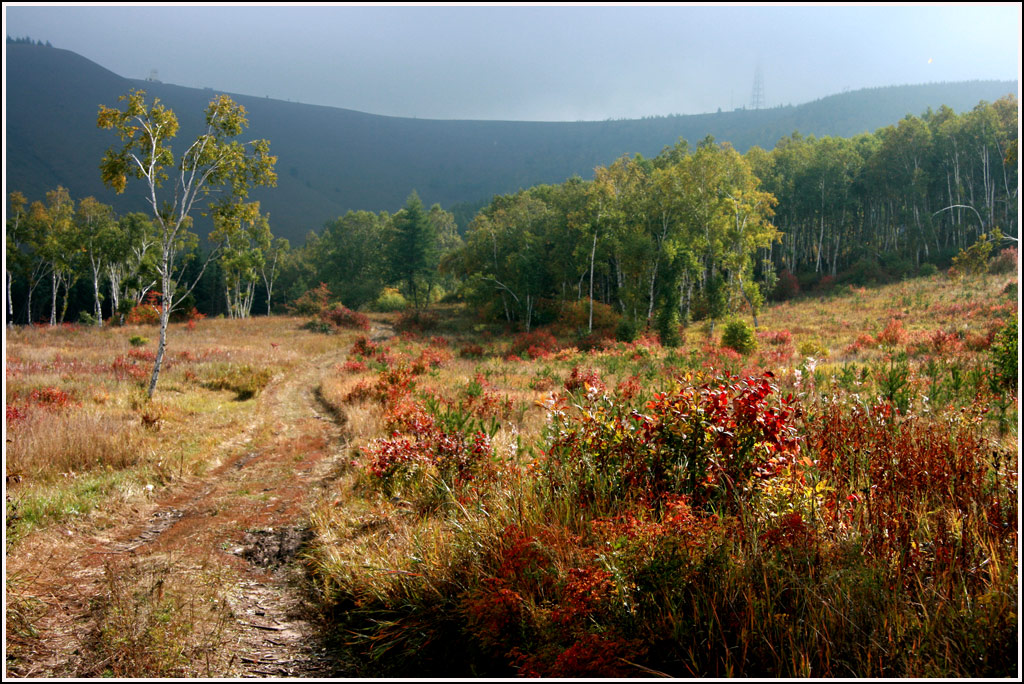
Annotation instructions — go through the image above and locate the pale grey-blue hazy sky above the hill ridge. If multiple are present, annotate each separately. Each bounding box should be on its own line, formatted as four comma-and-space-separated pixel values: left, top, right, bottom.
4, 3, 1021, 121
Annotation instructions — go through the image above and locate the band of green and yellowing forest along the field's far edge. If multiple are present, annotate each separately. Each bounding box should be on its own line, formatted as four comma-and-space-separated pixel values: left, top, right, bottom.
5, 95, 1018, 342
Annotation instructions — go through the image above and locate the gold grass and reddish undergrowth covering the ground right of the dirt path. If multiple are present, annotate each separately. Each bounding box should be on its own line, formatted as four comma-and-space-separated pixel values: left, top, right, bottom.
301, 276, 1018, 677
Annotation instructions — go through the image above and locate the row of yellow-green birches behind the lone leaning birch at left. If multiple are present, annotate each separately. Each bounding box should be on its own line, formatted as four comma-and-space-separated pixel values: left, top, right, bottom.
5, 186, 289, 326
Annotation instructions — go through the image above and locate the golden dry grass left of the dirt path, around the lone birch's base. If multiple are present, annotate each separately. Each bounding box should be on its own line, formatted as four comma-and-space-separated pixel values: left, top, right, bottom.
6, 318, 332, 542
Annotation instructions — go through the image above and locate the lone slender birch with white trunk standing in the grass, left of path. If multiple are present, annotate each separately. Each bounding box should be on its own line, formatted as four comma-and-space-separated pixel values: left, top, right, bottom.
96, 90, 276, 397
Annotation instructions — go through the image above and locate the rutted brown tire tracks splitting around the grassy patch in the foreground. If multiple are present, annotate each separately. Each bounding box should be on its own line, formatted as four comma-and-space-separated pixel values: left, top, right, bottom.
8, 349, 360, 677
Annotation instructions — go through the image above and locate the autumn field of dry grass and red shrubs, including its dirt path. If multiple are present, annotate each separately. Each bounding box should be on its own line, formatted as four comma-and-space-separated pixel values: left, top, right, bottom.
5, 275, 1019, 677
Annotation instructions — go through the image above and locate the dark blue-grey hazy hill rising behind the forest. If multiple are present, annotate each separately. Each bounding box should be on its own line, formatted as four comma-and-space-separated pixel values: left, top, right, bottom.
5, 43, 1018, 243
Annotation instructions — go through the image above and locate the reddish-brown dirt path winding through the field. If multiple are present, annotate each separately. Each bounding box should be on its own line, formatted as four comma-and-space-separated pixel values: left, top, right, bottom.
8, 342, 368, 677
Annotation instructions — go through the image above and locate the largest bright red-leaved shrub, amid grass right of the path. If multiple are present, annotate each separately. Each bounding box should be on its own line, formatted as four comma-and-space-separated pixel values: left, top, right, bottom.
543, 375, 798, 506
